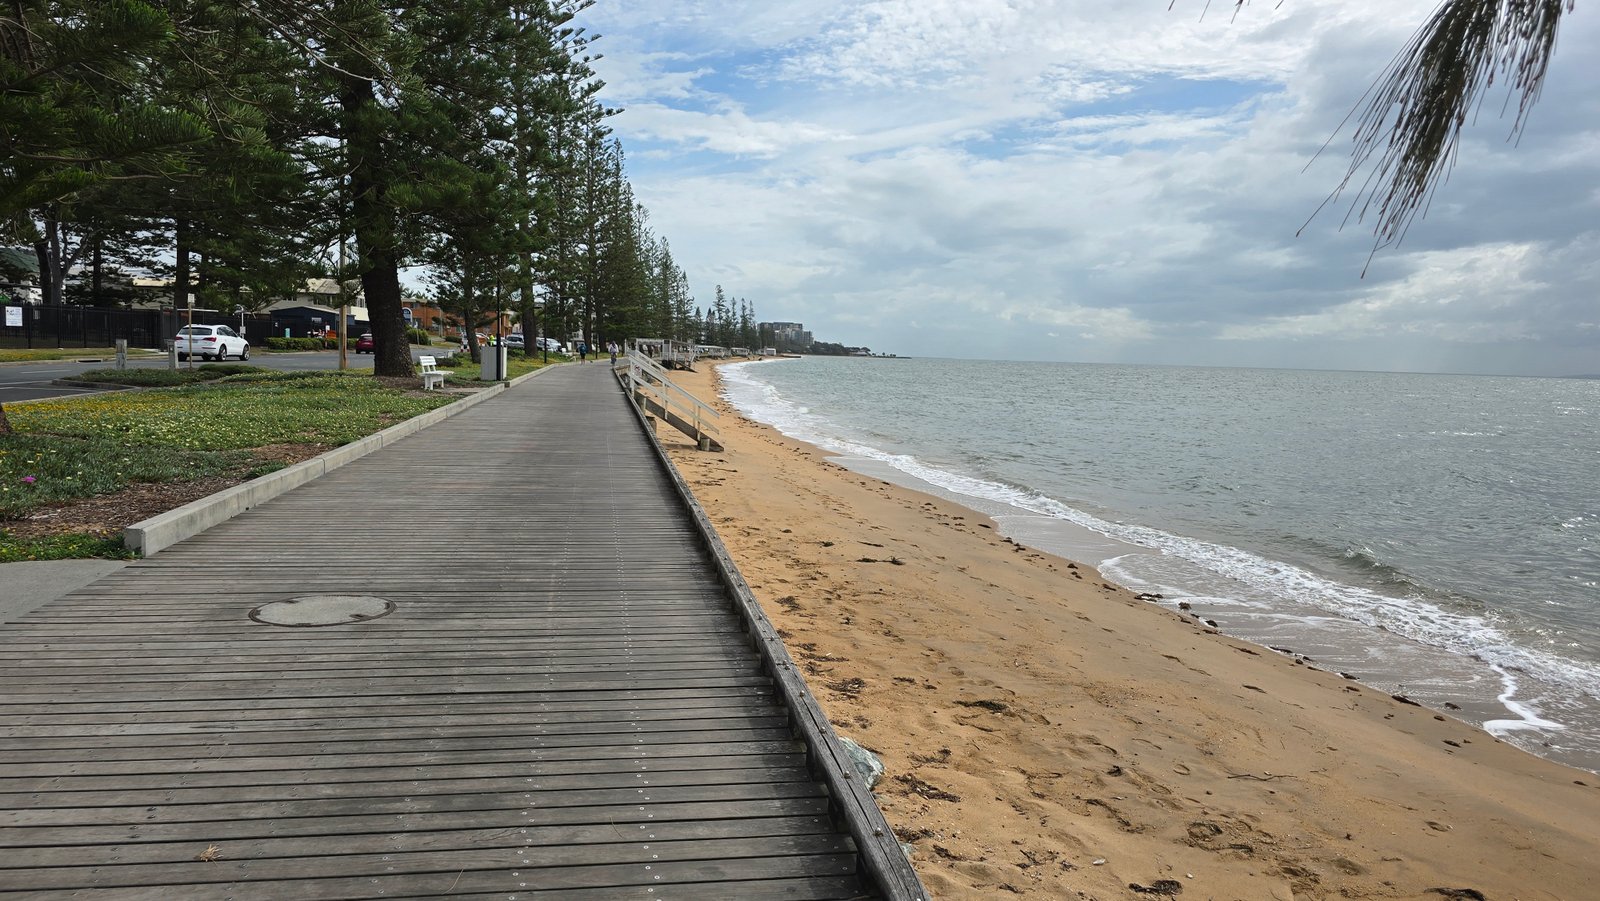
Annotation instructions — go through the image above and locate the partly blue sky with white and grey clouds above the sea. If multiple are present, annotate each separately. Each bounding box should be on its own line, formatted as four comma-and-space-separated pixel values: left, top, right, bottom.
578, 0, 1600, 374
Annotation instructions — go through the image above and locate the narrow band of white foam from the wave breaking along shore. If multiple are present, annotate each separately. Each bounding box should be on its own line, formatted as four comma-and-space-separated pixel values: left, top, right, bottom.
722, 362, 1600, 713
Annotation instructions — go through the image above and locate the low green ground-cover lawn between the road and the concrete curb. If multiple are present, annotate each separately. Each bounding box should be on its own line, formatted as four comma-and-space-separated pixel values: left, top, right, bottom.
0, 366, 456, 562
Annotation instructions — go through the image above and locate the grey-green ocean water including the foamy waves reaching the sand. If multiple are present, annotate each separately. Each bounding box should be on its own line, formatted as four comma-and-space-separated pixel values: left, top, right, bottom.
723, 357, 1600, 771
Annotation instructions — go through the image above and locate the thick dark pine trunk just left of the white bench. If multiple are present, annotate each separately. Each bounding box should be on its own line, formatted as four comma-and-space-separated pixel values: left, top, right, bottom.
339, 75, 416, 378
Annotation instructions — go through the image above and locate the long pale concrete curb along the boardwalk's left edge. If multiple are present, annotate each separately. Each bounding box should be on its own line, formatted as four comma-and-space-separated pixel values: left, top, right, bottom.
122, 366, 552, 557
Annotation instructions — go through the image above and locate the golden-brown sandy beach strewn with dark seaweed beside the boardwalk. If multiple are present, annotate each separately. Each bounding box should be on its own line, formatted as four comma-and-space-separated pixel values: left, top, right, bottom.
659, 366, 1600, 901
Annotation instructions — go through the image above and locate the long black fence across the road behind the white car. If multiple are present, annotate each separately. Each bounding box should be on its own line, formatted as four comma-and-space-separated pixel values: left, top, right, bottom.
0, 304, 284, 350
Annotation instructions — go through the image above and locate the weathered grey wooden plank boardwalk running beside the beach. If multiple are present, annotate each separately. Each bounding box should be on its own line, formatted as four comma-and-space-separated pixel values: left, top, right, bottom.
0, 365, 923, 901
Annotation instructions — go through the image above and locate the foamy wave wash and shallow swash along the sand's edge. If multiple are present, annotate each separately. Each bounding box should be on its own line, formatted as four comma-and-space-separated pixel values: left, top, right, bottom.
718, 358, 1600, 775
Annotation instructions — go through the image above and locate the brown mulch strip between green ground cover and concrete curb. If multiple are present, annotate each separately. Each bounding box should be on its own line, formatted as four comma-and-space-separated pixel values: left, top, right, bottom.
0, 445, 331, 538
